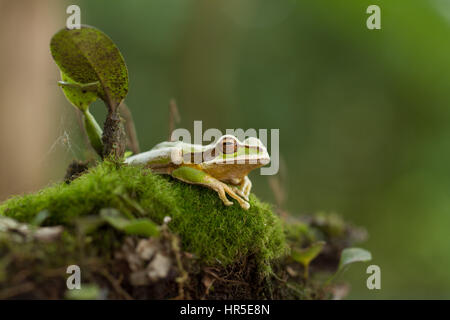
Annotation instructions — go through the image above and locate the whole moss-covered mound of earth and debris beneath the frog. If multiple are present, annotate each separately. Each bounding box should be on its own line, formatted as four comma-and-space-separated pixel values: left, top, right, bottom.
0, 161, 366, 299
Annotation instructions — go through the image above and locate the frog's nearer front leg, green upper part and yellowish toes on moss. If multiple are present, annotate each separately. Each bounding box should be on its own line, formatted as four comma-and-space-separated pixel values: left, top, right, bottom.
171, 166, 250, 210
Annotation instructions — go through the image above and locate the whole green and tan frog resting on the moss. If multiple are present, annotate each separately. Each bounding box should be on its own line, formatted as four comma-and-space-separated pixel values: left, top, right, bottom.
125, 135, 270, 210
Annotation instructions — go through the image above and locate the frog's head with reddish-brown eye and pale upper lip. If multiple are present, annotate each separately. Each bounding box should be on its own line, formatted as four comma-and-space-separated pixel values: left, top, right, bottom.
202, 135, 270, 180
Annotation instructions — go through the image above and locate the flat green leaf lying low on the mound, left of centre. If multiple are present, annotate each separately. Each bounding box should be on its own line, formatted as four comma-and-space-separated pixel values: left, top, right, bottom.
100, 208, 159, 237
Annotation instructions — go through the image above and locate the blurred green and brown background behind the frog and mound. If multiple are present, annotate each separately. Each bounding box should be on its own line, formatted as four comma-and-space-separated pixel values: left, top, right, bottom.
0, 0, 450, 299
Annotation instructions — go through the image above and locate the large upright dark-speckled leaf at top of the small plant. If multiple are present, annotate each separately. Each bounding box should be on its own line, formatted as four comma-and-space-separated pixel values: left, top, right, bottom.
50, 26, 128, 111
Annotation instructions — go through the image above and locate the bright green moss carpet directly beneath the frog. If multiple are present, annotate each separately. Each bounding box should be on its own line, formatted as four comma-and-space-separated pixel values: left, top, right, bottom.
0, 162, 286, 272
